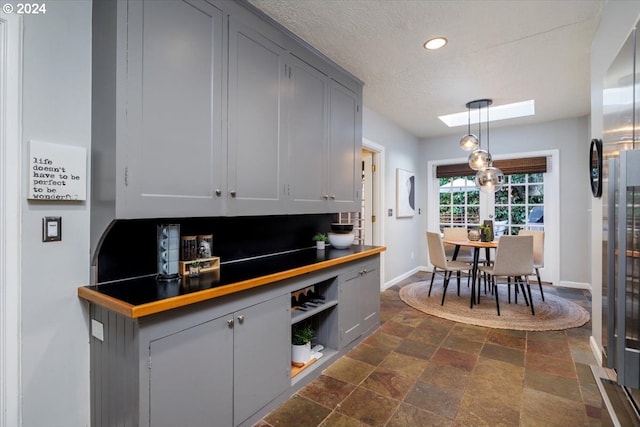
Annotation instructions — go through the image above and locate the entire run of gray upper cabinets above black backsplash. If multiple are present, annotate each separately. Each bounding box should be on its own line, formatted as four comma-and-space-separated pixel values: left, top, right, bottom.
91, 0, 362, 248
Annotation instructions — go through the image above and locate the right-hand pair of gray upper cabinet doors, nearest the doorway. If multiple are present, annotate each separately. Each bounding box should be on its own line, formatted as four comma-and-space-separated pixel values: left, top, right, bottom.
287, 55, 362, 213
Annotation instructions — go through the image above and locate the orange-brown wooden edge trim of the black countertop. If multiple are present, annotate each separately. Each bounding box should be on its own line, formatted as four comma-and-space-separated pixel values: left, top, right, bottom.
78, 246, 386, 318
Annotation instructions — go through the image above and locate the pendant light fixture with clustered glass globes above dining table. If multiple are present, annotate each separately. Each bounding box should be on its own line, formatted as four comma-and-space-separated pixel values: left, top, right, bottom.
460, 99, 504, 193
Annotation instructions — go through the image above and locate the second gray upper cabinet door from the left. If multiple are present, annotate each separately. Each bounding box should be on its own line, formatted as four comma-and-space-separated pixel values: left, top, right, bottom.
227, 19, 287, 215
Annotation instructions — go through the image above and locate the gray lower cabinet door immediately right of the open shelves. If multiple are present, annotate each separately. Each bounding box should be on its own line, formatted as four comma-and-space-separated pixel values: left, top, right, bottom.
338, 270, 362, 348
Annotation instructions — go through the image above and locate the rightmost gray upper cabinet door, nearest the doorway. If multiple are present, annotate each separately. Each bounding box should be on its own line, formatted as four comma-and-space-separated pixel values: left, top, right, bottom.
327, 80, 362, 212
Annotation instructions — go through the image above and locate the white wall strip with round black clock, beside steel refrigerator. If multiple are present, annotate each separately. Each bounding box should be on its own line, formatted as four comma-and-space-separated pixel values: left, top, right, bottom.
583, 1, 640, 358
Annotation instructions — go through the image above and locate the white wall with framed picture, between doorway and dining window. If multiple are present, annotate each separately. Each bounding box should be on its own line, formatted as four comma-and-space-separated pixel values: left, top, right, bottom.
363, 107, 425, 284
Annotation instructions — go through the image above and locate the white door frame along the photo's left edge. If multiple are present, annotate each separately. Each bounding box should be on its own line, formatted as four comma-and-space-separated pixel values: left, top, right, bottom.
0, 13, 22, 427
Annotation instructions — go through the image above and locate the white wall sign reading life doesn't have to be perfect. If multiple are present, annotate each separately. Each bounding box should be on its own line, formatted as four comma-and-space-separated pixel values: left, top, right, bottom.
28, 141, 87, 201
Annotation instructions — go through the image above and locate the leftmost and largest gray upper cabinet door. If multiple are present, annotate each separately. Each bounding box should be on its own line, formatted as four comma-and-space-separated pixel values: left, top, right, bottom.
122, 0, 225, 218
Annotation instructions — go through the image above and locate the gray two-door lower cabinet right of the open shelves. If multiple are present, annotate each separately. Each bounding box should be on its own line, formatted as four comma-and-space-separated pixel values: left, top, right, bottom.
338, 262, 380, 347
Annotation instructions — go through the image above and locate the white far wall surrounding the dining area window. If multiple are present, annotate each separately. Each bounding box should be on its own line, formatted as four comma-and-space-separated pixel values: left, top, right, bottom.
420, 117, 591, 286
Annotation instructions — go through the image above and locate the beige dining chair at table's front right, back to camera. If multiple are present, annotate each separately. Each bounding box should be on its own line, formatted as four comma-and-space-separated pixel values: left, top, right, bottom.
478, 235, 536, 316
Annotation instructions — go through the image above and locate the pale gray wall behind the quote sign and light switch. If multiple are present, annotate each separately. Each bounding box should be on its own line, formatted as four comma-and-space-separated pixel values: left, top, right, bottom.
20, 0, 91, 427
